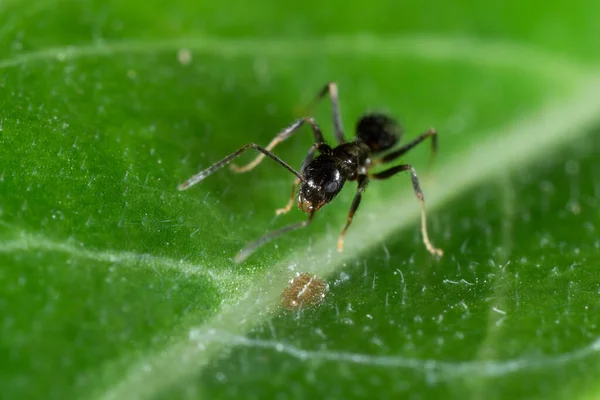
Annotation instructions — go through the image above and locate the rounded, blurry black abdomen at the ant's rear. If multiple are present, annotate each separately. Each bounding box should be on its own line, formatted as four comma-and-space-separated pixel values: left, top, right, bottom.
356, 113, 402, 153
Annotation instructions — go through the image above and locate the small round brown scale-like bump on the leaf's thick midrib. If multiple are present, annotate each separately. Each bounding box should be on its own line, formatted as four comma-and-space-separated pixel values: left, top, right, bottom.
281, 273, 329, 310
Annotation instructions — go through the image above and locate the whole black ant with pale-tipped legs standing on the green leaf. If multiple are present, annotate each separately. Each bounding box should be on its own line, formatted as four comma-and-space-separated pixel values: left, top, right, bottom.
178, 82, 443, 263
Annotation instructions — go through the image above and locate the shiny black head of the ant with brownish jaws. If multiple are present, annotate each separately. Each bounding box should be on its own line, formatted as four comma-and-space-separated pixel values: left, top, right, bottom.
298, 156, 346, 212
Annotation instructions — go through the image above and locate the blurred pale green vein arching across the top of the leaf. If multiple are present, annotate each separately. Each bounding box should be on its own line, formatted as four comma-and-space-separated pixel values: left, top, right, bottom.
0, 34, 593, 85
